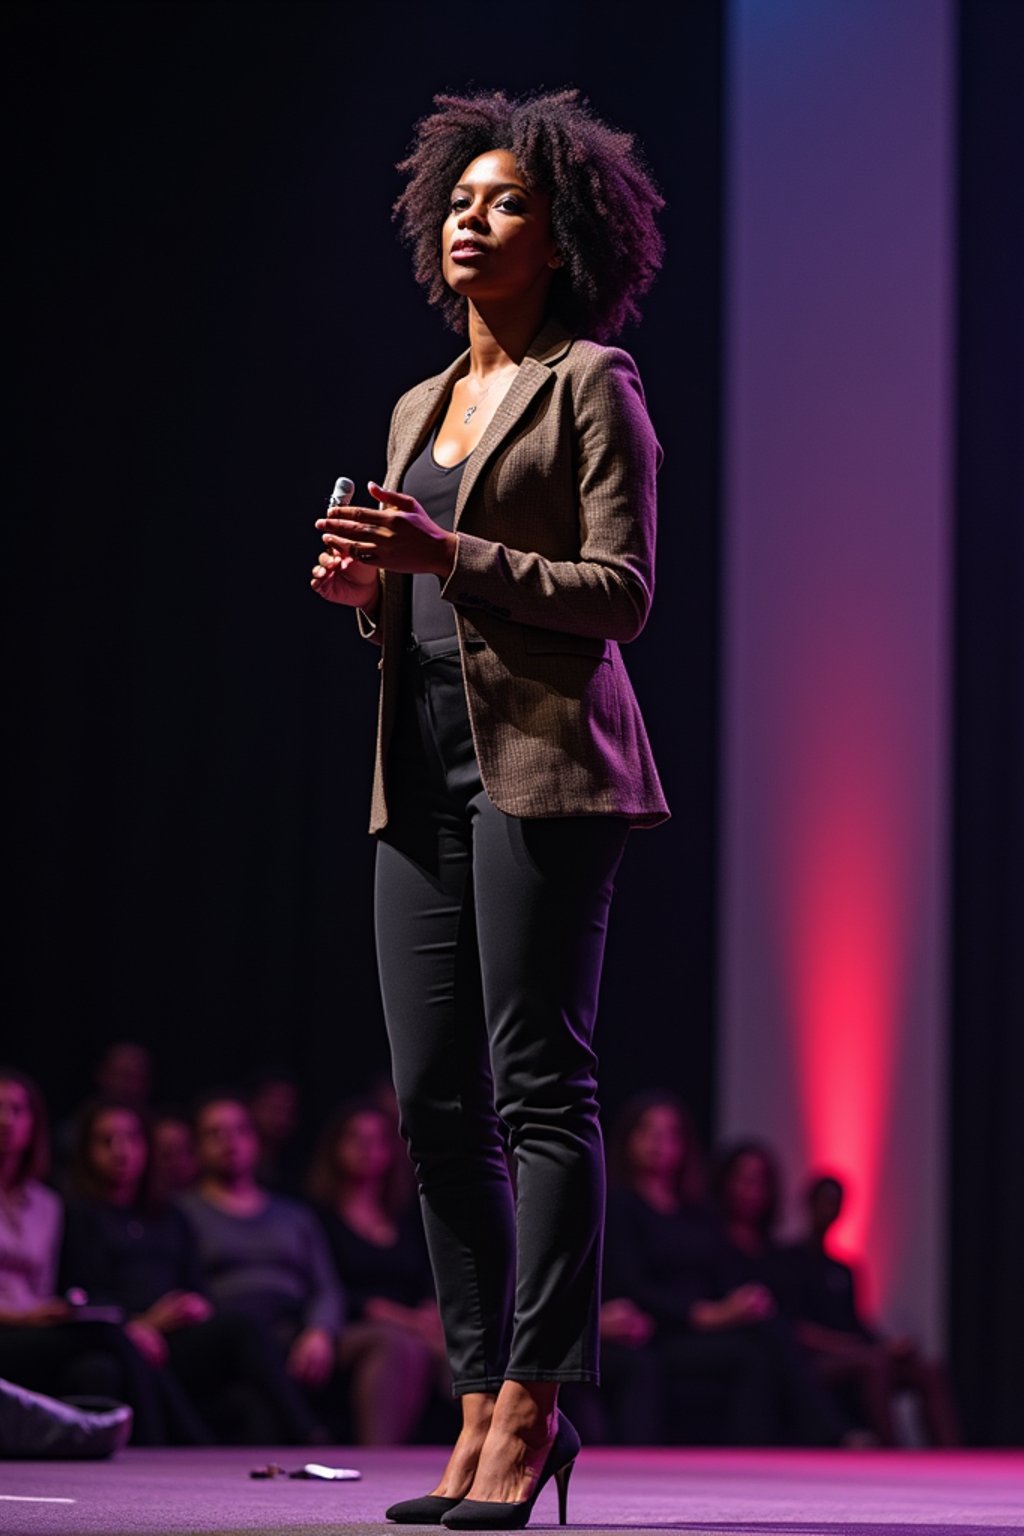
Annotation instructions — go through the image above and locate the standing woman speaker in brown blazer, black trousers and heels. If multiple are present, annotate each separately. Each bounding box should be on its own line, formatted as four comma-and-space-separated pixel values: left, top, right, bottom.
312, 91, 668, 1528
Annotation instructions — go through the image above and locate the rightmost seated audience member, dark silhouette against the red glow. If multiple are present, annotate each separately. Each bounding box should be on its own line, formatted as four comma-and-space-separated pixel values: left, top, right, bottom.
785, 1175, 960, 1445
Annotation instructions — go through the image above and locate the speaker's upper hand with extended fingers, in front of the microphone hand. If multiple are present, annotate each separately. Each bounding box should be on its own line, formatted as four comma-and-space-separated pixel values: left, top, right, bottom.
316, 481, 457, 581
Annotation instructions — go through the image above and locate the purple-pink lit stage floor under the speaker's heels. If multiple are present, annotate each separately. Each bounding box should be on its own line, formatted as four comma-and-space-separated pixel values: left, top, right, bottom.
0, 1447, 1024, 1536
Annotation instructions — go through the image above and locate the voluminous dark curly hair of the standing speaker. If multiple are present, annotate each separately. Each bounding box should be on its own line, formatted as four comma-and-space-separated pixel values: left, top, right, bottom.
393, 89, 665, 341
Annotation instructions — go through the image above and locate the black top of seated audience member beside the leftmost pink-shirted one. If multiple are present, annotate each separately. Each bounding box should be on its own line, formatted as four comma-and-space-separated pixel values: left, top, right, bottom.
60, 1200, 206, 1316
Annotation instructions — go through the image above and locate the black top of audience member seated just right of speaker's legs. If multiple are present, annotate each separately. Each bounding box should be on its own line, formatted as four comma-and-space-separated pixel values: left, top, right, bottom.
603, 1189, 731, 1333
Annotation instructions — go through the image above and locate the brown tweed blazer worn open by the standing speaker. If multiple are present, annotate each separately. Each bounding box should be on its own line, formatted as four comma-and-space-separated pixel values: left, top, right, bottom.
359, 321, 668, 833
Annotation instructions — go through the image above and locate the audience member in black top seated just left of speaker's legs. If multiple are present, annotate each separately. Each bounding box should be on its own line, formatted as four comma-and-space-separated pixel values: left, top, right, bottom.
309, 1100, 445, 1445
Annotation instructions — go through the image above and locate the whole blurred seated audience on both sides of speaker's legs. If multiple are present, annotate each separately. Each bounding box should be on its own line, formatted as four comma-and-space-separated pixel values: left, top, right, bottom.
0, 1043, 958, 1445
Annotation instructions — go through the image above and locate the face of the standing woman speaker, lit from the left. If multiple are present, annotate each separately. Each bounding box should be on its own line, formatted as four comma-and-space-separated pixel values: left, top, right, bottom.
441, 149, 560, 303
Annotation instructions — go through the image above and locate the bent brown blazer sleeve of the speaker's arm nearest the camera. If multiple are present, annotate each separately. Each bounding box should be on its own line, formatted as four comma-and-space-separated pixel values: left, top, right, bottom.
441, 347, 662, 641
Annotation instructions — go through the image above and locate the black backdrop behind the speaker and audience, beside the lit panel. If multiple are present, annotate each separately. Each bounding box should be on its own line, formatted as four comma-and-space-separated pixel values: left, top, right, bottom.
8, 0, 1024, 1444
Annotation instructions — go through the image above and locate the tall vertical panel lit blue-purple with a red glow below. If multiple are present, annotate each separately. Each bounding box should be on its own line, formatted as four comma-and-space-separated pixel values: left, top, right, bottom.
718, 0, 953, 1338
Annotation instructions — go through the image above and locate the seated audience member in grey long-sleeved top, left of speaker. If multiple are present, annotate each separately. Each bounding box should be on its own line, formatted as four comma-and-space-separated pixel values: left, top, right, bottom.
178, 1094, 344, 1413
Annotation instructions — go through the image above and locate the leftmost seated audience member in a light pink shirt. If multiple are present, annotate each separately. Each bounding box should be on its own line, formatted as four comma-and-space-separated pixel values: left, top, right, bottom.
0, 1068, 160, 1445
